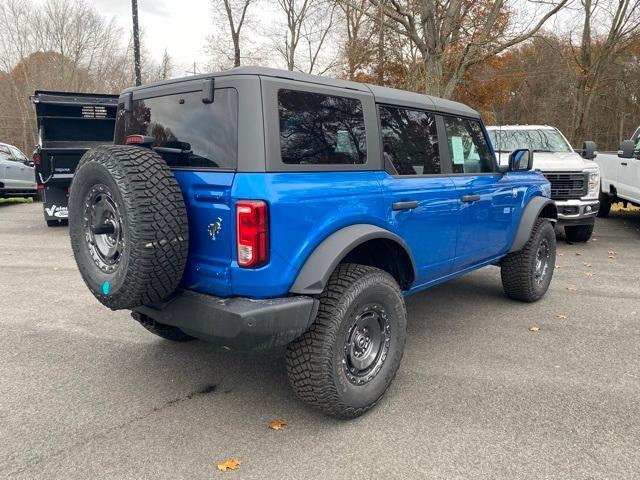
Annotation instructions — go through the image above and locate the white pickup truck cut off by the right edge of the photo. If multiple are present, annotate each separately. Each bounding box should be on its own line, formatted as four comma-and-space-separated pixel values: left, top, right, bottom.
596, 127, 640, 217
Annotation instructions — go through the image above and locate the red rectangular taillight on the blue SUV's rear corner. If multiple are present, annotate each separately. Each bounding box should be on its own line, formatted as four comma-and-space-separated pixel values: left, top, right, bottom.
236, 200, 269, 268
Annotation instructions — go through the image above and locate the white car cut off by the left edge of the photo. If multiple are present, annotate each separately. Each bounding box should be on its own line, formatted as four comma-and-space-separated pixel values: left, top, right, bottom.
0, 143, 38, 198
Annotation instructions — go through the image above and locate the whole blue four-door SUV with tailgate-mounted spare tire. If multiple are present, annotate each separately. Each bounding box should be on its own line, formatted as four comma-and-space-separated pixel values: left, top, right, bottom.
69, 67, 557, 418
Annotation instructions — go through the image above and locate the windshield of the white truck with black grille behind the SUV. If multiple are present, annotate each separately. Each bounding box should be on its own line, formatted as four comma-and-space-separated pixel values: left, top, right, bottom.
489, 129, 571, 152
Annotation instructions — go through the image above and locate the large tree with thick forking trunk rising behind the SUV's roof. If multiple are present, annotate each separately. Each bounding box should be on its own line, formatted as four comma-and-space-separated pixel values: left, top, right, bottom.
360, 0, 568, 98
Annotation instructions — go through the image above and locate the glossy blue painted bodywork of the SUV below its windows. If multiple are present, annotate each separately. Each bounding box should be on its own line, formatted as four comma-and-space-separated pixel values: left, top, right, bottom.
174, 170, 549, 298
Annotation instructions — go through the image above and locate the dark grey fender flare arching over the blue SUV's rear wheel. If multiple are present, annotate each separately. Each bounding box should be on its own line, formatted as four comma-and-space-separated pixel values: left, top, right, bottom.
289, 224, 416, 295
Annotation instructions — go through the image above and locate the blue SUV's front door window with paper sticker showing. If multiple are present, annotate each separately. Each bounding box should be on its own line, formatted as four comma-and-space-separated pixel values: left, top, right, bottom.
444, 116, 494, 173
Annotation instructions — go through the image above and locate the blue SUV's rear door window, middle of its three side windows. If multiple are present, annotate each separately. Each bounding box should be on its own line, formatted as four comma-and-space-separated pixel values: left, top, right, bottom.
379, 106, 440, 175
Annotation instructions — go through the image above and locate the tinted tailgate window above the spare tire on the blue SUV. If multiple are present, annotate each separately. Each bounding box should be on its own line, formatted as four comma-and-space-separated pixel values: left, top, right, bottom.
115, 88, 238, 170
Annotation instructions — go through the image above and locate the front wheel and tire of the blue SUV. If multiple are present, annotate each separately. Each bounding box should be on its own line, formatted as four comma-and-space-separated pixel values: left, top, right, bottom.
500, 218, 556, 302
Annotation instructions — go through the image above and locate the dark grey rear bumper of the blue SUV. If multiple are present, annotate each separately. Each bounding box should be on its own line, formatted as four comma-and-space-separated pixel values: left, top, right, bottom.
134, 290, 318, 350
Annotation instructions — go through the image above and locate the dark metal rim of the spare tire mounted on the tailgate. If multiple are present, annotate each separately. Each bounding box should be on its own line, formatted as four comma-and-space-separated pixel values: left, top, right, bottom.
84, 184, 125, 273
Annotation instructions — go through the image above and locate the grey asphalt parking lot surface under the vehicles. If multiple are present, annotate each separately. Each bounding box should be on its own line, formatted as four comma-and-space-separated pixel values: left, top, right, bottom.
0, 204, 640, 480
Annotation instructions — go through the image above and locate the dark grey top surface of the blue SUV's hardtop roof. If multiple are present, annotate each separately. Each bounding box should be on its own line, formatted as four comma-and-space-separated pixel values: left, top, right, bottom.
121, 66, 480, 118
